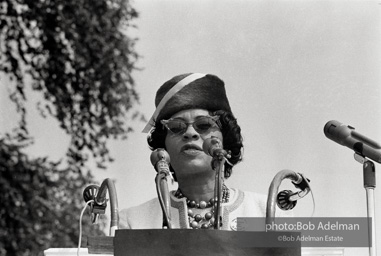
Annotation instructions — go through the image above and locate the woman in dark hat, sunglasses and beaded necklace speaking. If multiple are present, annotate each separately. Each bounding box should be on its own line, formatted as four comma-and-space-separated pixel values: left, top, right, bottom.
119, 73, 284, 230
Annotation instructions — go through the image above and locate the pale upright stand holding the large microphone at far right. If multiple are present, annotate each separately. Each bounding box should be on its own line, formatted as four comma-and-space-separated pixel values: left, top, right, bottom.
354, 153, 377, 256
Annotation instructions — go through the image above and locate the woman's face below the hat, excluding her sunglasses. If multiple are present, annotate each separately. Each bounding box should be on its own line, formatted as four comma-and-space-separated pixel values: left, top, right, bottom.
165, 109, 223, 179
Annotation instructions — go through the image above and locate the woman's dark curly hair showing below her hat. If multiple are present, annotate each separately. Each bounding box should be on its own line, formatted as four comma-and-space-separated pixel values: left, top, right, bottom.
147, 110, 243, 179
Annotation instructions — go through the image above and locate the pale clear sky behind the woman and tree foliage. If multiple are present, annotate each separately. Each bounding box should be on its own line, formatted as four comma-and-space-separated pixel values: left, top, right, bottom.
0, 0, 381, 255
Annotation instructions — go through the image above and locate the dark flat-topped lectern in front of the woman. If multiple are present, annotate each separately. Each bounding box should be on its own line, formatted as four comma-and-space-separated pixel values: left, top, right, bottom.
88, 229, 301, 256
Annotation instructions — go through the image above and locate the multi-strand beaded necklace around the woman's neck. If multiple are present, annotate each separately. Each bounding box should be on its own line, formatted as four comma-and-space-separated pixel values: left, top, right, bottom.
175, 184, 230, 229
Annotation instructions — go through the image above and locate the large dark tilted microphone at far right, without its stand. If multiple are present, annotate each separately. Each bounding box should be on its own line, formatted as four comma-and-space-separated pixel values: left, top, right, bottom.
324, 120, 381, 163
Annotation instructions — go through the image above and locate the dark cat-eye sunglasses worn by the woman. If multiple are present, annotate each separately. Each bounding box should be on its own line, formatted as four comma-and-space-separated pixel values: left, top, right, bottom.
161, 116, 220, 135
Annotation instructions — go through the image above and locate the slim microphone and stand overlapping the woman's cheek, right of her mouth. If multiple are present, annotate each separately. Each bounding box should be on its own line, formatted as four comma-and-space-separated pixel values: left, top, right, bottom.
212, 149, 227, 229
